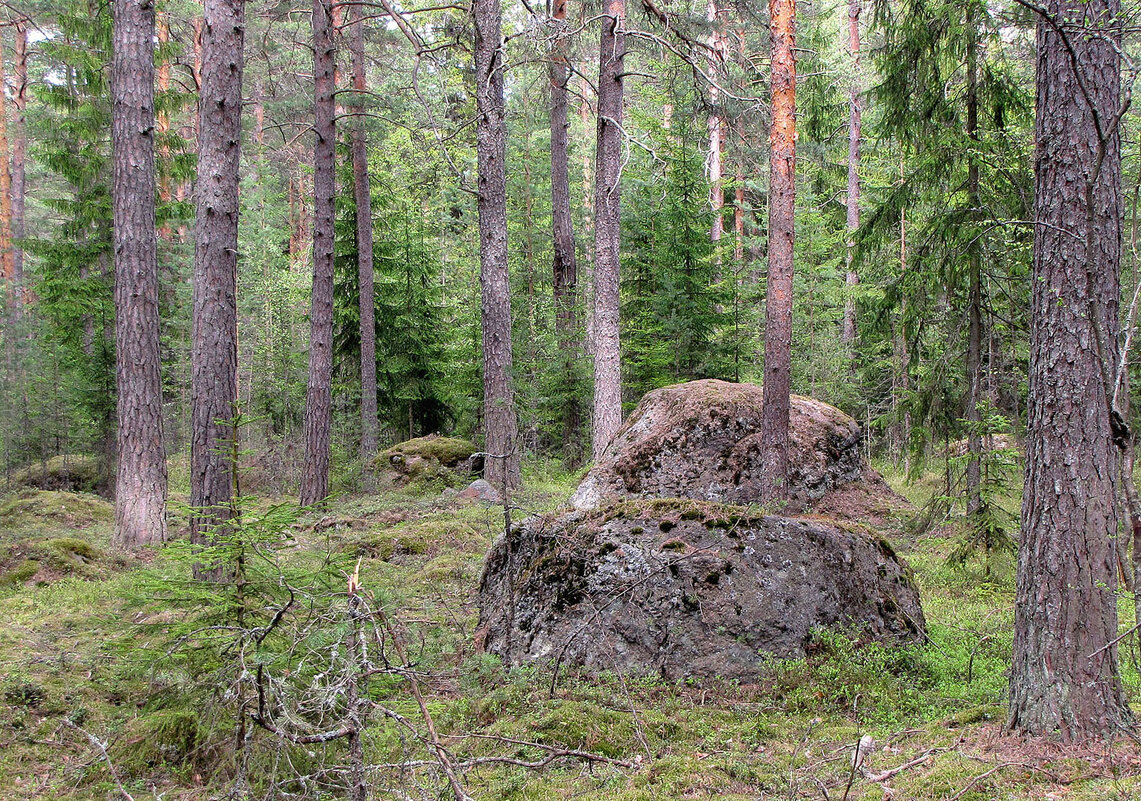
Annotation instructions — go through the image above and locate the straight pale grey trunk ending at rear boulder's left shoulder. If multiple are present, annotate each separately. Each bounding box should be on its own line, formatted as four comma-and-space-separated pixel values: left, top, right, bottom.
593, 0, 626, 460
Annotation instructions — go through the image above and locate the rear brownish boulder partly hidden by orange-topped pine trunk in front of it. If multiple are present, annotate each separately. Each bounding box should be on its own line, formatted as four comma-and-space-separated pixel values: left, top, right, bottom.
571, 379, 862, 509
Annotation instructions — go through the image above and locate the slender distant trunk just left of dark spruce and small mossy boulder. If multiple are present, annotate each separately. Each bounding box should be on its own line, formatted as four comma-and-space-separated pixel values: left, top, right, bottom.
351, 6, 377, 490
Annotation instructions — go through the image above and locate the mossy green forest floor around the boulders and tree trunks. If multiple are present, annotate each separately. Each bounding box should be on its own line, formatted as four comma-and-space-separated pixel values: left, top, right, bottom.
0, 460, 1141, 801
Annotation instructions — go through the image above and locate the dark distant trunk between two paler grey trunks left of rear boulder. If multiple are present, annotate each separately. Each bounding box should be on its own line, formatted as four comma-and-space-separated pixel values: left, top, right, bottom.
550, 0, 582, 466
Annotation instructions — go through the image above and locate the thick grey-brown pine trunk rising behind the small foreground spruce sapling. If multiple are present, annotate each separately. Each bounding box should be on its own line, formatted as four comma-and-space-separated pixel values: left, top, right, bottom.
191, 0, 245, 542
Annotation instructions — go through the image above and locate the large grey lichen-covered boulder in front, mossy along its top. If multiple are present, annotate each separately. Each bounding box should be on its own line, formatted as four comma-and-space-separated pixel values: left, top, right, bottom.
478, 500, 924, 680
